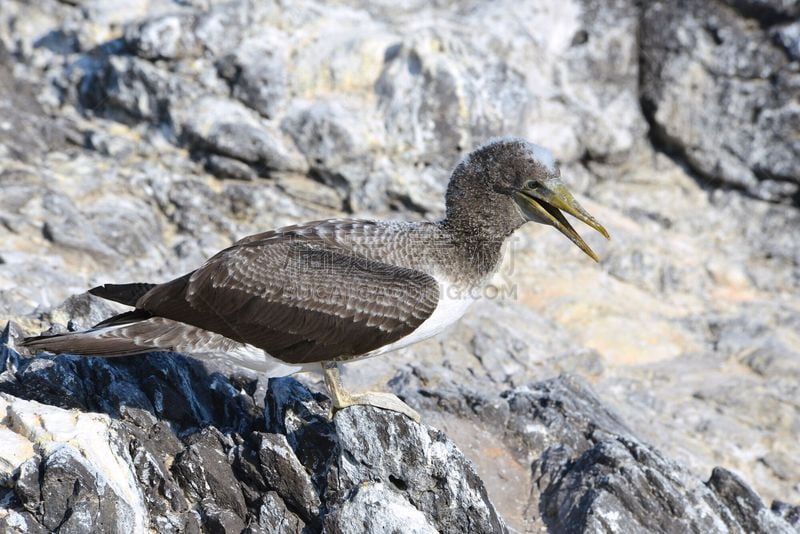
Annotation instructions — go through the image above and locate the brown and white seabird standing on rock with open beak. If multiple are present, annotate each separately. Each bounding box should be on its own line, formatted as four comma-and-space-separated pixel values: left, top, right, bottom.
21, 137, 609, 421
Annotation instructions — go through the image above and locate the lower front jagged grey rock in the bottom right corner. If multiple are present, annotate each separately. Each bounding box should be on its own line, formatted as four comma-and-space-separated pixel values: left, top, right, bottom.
534, 438, 792, 533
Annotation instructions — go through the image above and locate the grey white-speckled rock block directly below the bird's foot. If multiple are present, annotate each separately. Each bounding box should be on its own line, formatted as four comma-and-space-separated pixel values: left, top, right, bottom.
328, 407, 506, 532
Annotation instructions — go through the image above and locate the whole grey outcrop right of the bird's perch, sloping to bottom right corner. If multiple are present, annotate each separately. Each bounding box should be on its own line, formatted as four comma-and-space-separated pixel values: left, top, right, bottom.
402, 376, 792, 532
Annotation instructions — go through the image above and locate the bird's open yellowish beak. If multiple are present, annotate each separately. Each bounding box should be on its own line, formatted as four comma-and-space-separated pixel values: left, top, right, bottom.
514, 178, 611, 262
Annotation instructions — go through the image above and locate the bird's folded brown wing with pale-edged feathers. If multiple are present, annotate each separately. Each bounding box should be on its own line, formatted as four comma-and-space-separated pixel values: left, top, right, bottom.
137, 224, 439, 363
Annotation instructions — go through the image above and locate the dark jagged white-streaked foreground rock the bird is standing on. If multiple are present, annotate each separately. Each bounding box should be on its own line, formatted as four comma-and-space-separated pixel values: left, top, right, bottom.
0, 327, 506, 533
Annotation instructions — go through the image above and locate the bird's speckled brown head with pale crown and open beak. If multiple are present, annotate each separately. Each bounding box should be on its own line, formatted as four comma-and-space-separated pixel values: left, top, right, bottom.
446, 138, 609, 261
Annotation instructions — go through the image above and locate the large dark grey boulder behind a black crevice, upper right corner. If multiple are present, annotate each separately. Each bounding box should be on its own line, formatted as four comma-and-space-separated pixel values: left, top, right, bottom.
642, 0, 800, 200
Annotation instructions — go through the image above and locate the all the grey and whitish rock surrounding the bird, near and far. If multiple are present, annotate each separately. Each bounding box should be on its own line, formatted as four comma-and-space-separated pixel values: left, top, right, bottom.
0, 0, 800, 532
